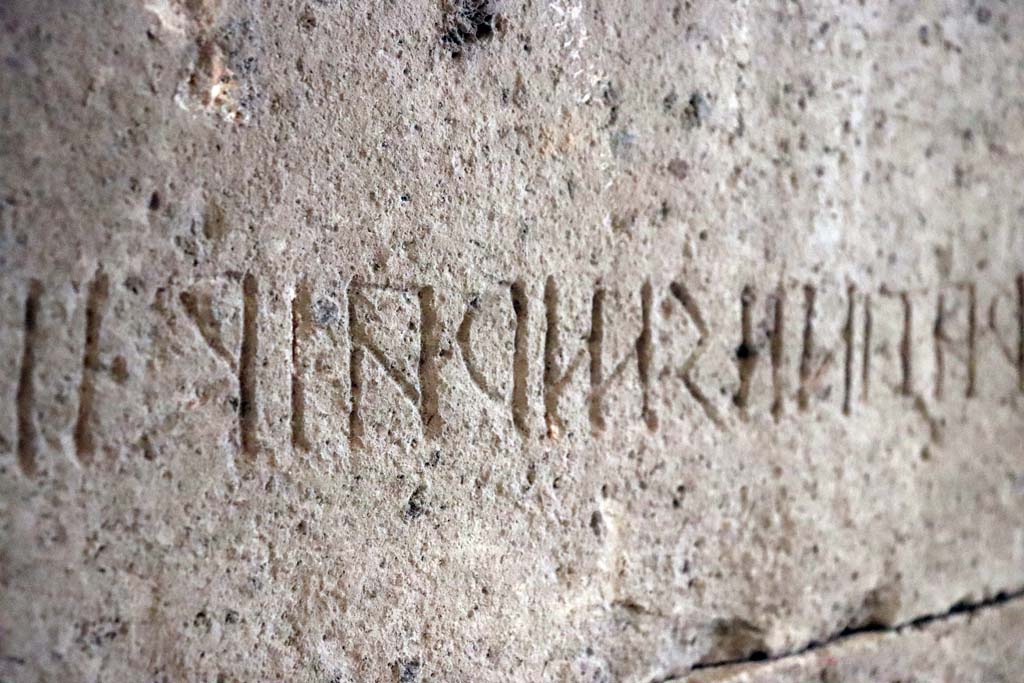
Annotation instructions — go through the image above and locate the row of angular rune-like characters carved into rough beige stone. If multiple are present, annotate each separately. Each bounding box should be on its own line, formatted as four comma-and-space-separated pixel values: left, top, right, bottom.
8, 269, 1024, 475
